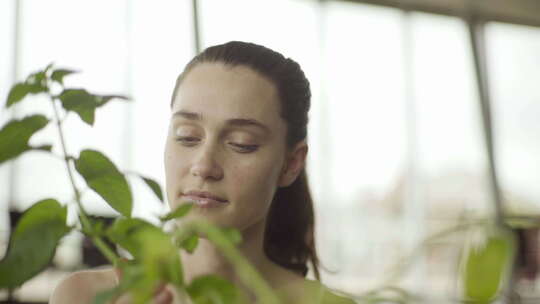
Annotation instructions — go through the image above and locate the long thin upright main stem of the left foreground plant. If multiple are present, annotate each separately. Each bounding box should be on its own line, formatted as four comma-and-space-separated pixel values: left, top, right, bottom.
50, 96, 118, 264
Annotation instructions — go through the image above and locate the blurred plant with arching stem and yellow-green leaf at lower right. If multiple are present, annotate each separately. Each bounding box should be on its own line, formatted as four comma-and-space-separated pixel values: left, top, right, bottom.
357, 217, 520, 304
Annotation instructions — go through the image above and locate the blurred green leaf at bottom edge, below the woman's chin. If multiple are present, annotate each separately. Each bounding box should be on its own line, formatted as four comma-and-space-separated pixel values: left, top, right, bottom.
186, 275, 243, 304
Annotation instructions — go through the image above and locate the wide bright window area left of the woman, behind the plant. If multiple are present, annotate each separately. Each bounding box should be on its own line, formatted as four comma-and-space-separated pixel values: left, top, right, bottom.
10, 0, 193, 217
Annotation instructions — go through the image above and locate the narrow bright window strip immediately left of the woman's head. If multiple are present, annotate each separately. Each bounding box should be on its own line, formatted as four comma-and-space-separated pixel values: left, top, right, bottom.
129, 0, 194, 219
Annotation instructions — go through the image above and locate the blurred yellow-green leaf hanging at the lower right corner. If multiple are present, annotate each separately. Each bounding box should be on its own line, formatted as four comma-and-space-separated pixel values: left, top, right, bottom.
463, 232, 514, 304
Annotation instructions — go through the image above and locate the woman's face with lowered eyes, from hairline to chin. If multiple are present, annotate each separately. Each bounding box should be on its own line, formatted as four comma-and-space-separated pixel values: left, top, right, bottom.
164, 63, 292, 231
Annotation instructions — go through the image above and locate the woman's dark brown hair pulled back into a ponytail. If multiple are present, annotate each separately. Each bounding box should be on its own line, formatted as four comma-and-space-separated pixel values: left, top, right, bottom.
171, 41, 319, 279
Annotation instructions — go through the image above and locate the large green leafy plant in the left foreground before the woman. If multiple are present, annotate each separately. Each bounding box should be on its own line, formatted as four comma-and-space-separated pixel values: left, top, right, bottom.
0, 64, 279, 304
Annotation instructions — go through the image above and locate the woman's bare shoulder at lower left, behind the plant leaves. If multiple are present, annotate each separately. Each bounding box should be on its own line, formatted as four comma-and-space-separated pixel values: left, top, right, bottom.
49, 267, 116, 304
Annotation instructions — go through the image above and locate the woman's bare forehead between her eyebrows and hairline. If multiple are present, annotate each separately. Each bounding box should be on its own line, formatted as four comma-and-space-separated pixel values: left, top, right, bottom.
173, 63, 282, 127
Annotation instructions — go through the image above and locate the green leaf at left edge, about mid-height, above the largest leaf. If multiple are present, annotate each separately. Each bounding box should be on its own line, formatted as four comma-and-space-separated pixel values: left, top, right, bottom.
0, 115, 50, 164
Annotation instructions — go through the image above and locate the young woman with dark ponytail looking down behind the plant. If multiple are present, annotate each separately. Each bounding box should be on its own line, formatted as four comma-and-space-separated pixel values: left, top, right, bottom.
51, 41, 354, 303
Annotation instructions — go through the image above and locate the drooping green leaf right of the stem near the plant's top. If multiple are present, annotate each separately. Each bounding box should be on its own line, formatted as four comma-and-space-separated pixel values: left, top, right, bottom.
58, 89, 99, 126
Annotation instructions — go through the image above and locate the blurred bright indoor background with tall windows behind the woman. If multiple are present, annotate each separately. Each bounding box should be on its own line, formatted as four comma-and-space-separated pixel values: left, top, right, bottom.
0, 0, 540, 303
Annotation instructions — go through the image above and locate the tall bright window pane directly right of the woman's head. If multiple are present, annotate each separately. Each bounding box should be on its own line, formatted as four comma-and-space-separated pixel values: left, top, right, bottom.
317, 2, 407, 293
